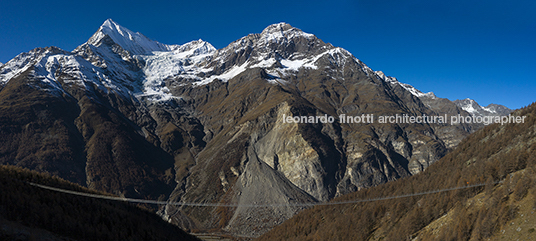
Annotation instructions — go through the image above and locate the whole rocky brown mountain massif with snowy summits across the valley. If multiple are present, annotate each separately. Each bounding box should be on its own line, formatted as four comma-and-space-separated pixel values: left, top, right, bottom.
0, 20, 506, 236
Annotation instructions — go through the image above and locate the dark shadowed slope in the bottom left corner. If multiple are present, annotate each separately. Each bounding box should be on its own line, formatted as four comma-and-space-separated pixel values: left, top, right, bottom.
0, 165, 199, 241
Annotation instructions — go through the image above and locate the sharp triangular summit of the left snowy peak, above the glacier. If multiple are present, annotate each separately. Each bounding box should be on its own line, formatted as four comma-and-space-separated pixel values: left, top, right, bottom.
87, 19, 179, 55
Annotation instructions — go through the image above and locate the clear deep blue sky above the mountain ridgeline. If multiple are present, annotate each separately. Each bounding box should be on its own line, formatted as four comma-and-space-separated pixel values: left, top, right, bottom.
0, 0, 536, 108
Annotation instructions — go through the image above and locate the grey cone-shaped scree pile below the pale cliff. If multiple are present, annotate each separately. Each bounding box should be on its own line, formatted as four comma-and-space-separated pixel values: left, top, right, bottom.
224, 147, 316, 236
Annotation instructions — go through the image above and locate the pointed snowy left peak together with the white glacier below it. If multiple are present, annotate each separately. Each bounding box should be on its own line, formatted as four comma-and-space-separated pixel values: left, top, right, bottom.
69, 19, 220, 101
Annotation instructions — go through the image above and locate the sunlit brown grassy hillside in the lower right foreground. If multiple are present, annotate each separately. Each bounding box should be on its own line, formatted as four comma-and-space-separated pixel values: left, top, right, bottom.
260, 104, 536, 240
